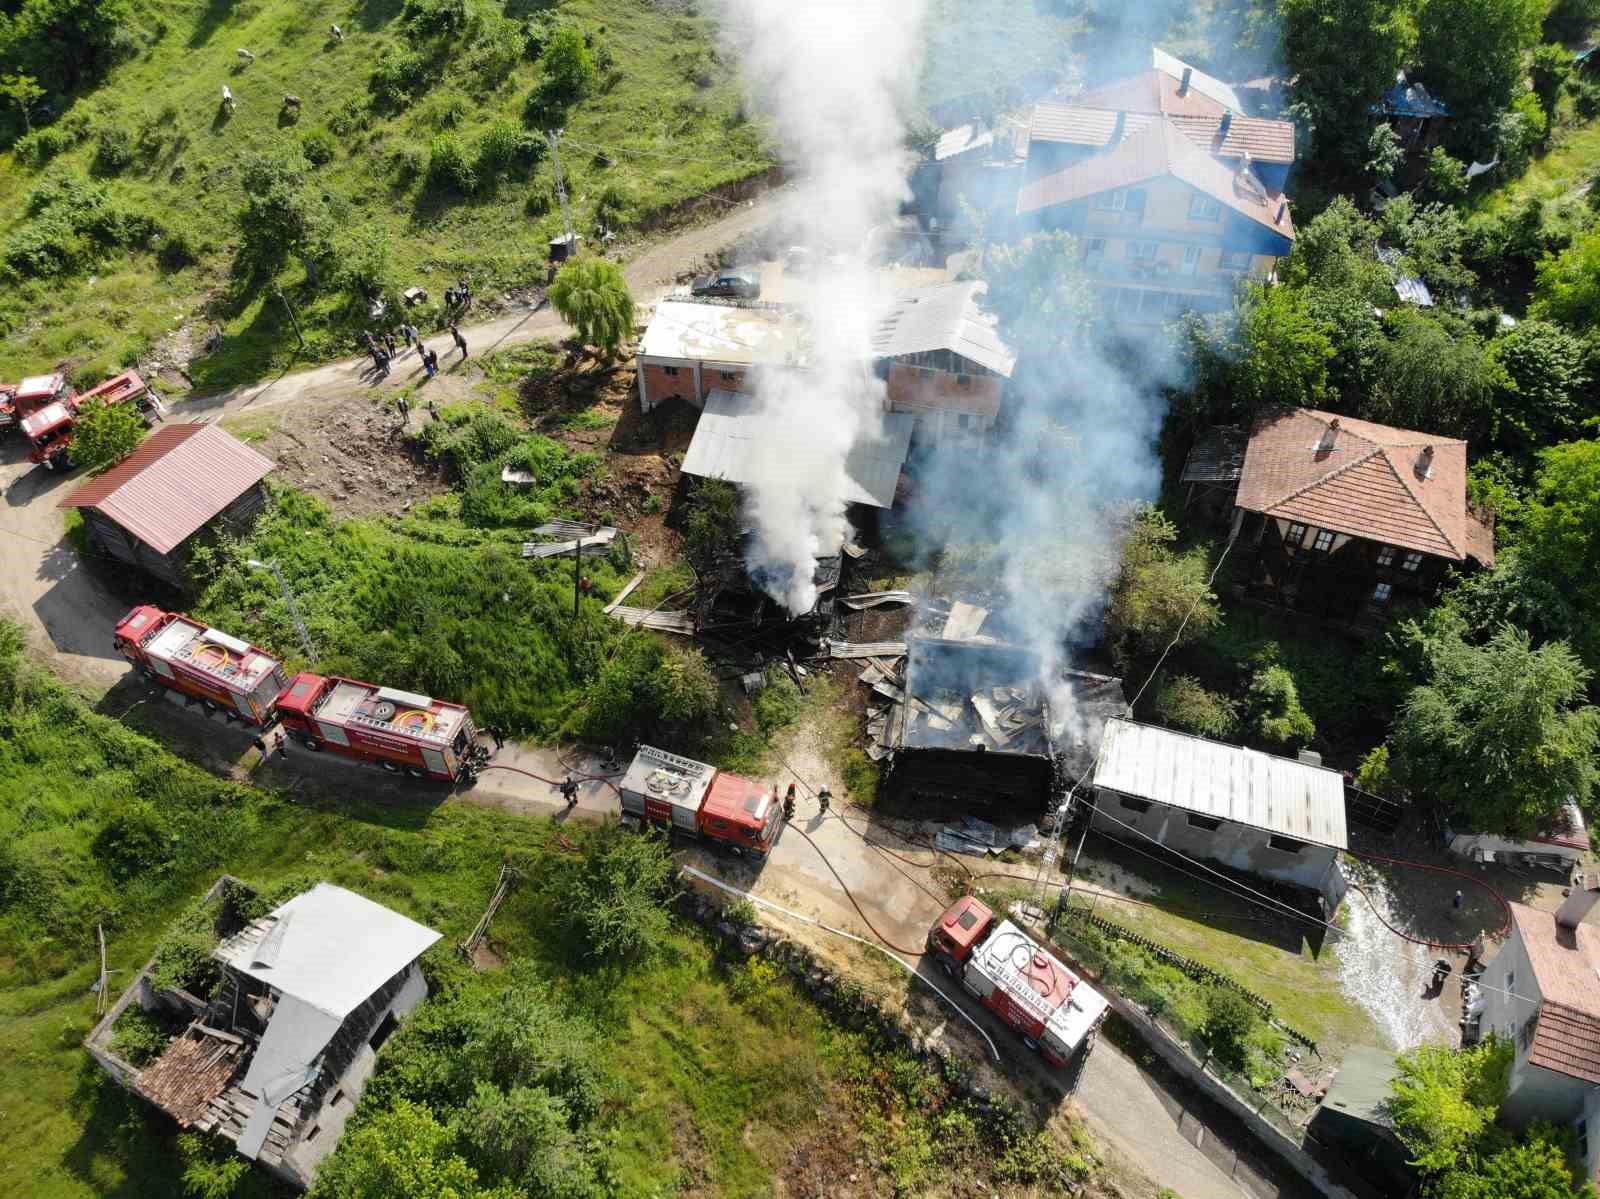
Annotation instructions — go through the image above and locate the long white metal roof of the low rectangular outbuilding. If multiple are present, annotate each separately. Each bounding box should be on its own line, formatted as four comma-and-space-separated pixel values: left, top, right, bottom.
1094, 719, 1349, 850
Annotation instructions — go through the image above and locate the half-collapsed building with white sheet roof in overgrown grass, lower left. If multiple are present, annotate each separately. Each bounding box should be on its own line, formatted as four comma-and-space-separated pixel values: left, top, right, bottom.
86, 877, 438, 1189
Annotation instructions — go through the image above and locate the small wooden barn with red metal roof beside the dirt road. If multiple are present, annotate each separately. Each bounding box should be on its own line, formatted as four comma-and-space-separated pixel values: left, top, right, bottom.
59, 424, 272, 587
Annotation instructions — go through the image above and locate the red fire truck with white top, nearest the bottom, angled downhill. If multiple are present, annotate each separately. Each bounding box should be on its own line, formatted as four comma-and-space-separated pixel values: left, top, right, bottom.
928, 895, 1109, 1066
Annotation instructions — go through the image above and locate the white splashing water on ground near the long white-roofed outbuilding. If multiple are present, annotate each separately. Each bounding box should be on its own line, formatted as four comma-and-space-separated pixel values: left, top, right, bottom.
1338, 879, 1454, 1050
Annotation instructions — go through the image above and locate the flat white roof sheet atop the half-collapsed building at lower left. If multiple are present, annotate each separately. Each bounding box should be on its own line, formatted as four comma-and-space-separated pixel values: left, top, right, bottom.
216, 882, 438, 1020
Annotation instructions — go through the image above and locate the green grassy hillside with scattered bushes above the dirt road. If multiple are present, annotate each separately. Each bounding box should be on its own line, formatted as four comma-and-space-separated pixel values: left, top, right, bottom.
0, 0, 765, 387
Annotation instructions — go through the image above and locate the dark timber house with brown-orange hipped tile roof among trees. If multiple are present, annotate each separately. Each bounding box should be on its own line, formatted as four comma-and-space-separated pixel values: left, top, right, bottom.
1182, 408, 1494, 632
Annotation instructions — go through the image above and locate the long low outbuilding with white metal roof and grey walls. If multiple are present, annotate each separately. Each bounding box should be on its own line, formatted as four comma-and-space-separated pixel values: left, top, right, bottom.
1093, 719, 1349, 916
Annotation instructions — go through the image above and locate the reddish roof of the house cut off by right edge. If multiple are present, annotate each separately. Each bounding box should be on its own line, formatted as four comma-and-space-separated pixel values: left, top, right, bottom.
1510, 903, 1600, 1082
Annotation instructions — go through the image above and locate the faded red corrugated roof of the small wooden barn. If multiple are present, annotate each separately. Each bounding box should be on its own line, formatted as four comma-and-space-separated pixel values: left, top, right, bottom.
58, 424, 272, 554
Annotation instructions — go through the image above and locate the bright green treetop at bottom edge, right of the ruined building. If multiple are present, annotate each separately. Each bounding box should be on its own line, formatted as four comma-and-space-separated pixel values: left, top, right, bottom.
310, 1100, 492, 1199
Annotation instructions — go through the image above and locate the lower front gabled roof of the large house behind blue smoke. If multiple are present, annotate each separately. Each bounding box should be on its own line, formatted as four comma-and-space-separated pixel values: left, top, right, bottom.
1016, 118, 1294, 240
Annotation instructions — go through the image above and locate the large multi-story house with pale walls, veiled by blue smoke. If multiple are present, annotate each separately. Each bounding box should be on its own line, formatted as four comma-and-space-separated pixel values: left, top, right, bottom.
1016, 51, 1294, 325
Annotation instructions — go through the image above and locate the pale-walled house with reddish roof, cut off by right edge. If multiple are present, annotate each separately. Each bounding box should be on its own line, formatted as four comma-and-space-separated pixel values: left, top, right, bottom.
1478, 880, 1600, 1180
